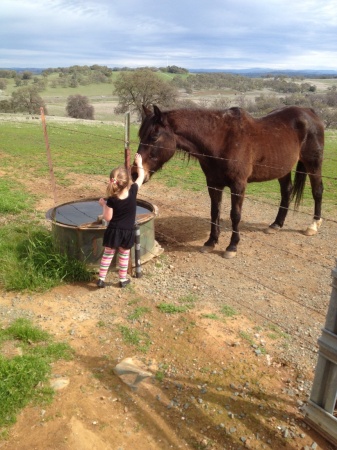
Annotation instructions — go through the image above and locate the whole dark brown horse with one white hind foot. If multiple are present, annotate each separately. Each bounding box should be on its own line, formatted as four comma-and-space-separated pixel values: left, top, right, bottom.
132, 106, 324, 258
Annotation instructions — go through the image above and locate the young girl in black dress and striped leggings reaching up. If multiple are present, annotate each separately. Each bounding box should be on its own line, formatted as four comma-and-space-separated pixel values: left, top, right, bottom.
97, 153, 144, 288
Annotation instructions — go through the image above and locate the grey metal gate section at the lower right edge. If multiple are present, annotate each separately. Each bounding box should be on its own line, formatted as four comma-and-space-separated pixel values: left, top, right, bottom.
304, 259, 337, 445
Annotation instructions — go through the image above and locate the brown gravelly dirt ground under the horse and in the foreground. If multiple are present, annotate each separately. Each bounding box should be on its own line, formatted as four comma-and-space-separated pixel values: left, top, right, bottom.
0, 169, 337, 450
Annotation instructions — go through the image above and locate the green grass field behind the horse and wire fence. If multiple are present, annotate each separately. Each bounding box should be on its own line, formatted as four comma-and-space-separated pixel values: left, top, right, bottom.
0, 120, 337, 206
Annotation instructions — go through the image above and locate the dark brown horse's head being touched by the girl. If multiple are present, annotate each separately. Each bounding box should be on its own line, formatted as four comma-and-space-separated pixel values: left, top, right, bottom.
131, 105, 176, 182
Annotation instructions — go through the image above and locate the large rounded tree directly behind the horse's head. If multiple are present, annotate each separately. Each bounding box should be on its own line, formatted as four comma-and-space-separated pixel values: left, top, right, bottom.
114, 68, 178, 118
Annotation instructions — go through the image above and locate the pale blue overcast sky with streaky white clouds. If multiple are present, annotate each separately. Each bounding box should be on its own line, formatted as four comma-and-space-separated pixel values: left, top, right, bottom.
0, 0, 337, 70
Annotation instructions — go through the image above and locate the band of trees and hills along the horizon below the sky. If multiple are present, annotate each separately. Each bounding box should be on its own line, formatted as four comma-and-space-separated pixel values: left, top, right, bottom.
0, 65, 337, 127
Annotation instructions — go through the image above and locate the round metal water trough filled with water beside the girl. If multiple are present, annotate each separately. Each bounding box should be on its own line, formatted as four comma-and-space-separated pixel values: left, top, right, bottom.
46, 198, 163, 270
